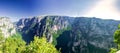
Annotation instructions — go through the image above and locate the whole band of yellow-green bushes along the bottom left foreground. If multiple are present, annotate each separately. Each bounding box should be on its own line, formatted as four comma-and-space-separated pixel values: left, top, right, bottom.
0, 33, 60, 53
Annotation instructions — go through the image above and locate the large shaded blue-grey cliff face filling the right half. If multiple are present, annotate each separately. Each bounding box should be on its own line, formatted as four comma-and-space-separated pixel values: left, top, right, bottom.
56, 17, 120, 53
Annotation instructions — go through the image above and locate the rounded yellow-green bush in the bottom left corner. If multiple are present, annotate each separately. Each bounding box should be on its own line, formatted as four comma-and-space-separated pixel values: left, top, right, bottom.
2, 35, 26, 53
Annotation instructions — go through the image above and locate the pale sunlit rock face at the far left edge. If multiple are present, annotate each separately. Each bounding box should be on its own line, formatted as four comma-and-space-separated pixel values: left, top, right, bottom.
0, 17, 16, 37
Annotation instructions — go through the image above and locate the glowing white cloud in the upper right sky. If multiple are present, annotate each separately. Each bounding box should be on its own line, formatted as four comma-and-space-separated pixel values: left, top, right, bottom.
84, 0, 120, 20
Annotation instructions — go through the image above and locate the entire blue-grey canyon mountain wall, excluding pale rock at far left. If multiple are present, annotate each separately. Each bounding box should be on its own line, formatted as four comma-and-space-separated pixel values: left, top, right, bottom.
16, 16, 120, 53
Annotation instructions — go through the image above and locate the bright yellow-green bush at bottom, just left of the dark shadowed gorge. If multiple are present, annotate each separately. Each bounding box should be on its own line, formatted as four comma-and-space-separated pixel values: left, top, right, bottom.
26, 36, 59, 53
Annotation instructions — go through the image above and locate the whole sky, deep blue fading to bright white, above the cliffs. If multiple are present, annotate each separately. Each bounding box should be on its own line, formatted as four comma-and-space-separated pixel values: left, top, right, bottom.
0, 0, 120, 21
